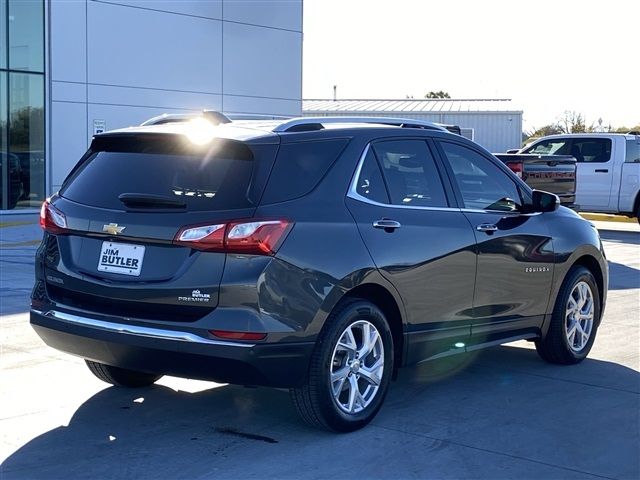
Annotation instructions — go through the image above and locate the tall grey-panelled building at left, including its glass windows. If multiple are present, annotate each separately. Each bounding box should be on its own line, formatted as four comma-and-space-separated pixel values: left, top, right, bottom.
0, 0, 302, 211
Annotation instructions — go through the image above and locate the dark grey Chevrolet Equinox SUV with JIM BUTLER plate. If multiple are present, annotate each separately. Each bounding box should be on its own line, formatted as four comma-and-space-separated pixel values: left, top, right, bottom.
31, 118, 608, 431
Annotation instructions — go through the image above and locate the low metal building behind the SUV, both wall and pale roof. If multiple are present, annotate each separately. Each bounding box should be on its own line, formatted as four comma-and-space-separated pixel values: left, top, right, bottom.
302, 98, 522, 153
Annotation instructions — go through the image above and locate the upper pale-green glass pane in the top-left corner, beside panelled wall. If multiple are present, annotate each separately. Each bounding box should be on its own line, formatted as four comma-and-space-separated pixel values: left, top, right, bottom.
5, 0, 44, 72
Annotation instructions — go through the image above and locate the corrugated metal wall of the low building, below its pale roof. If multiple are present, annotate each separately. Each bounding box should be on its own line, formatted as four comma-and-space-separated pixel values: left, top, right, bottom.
304, 111, 522, 153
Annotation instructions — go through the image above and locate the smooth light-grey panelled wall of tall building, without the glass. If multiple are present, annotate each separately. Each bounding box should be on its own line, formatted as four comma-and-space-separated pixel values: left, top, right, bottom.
48, 0, 302, 193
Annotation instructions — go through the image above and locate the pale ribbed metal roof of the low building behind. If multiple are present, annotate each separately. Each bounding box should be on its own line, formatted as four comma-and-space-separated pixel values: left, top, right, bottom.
302, 98, 522, 114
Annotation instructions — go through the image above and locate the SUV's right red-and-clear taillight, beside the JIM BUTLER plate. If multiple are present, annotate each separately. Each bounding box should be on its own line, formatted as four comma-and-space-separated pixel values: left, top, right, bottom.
174, 220, 293, 255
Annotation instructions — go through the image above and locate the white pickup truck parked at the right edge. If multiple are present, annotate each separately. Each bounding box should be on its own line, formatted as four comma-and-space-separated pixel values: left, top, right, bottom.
518, 132, 640, 222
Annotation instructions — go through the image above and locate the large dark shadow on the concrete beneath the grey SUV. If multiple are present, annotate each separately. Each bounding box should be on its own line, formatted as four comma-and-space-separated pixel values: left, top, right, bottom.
0, 346, 640, 480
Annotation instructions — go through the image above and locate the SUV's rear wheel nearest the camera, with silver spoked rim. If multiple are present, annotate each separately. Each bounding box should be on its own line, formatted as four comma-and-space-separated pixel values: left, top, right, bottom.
290, 299, 394, 432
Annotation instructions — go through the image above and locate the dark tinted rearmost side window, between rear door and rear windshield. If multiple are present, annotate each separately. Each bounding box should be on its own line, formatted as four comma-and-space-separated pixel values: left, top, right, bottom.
262, 138, 349, 204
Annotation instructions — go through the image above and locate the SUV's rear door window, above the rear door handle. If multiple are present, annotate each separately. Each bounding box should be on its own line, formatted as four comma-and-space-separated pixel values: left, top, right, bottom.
373, 140, 448, 207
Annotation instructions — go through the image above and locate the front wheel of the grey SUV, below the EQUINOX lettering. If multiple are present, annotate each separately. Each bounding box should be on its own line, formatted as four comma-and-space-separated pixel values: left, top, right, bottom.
536, 266, 601, 365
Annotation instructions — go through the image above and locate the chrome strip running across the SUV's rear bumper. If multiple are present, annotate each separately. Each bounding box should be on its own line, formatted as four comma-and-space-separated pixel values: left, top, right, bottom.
34, 310, 255, 348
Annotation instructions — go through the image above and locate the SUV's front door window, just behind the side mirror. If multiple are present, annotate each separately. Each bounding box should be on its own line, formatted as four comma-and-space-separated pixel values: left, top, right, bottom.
441, 142, 522, 211
